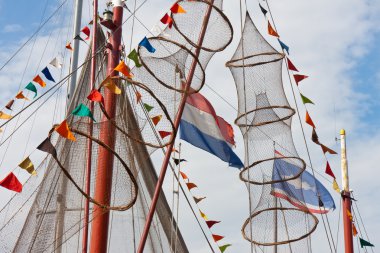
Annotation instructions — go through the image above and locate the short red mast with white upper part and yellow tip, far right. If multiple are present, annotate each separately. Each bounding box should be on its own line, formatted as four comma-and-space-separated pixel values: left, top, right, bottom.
340, 129, 354, 253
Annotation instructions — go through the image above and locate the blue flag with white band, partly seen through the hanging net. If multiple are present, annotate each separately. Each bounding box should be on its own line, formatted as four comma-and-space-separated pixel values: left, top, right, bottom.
272, 159, 335, 213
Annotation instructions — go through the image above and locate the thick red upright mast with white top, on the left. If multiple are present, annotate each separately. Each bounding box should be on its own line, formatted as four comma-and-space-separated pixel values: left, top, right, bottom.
90, 0, 123, 253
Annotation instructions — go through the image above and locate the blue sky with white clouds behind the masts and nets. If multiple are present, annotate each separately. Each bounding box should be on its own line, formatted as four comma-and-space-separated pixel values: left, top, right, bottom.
0, 0, 380, 252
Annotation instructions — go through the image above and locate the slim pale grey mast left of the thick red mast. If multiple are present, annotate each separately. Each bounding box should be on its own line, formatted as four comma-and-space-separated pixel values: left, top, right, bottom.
67, 0, 83, 101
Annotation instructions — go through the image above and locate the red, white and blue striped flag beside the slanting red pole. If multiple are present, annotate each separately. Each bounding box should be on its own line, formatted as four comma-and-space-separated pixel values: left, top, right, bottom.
180, 93, 244, 169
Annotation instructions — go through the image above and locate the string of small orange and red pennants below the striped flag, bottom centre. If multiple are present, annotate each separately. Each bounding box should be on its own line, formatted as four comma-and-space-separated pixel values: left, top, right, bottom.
172, 157, 232, 253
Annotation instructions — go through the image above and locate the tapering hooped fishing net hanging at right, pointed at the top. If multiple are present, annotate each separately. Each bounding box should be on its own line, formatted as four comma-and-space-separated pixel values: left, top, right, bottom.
226, 13, 318, 247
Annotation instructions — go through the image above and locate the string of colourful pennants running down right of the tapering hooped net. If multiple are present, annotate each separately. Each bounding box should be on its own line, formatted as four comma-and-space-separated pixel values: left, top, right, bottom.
259, 3, 341, 194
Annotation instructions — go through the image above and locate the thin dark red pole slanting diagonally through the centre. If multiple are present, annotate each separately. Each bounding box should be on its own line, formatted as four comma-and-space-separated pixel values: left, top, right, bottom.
137, 0, 214, 253
